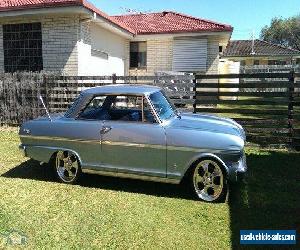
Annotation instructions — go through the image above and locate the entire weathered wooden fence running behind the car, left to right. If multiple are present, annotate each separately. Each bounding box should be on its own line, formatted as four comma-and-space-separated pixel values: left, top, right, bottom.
0, 72, 300, 147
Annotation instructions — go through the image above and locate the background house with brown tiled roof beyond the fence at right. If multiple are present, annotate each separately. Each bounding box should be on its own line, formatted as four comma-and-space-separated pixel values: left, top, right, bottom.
221, 39, 300, 66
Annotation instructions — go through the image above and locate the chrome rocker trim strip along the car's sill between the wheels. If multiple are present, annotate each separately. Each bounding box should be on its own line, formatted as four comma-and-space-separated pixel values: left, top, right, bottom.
82, 169, 180, 184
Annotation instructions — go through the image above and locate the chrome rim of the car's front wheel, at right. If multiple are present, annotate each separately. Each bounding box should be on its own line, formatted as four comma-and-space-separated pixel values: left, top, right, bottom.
193, 160, 224, 201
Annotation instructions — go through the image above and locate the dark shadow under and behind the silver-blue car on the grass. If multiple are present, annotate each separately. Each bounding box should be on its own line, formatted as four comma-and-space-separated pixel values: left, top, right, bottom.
2, 160, 194, 200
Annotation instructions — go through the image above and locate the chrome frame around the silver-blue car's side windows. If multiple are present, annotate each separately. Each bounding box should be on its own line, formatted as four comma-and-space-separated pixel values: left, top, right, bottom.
75, 93, 160, 124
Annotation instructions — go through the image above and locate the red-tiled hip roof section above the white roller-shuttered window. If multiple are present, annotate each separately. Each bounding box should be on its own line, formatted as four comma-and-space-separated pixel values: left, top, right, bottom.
114, 11, 233, 34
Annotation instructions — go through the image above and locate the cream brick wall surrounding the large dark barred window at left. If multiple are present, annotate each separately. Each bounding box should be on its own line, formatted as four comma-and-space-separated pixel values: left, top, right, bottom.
0, 16, 79, 75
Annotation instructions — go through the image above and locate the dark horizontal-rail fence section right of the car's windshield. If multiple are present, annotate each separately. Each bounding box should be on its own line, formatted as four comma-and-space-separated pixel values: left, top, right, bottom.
194, 72, 300, 148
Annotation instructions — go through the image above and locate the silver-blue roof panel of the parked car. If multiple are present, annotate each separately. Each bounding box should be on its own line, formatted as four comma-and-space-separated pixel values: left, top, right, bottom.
83, 84, 161, 95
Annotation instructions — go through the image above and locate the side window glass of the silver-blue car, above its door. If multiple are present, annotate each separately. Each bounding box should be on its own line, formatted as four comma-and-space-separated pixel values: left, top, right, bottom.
78, 95, 155, 123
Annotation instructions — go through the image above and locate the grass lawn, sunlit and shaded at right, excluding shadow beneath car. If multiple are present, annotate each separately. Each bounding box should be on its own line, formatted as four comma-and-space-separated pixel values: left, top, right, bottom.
0, 128, 300, 249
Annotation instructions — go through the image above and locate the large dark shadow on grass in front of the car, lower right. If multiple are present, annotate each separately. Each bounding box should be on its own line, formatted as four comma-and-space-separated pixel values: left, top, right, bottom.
228, 151, 300, 249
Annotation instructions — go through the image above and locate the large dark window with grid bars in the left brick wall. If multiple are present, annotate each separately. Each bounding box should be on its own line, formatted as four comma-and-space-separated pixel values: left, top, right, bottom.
3, 23, 43, 72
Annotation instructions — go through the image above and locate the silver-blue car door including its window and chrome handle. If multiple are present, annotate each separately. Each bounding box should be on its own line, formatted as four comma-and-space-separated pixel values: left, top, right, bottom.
101, 96, 166, 177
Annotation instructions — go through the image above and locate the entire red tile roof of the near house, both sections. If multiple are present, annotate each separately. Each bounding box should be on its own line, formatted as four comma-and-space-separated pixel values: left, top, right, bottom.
0, 0, 233, 34
